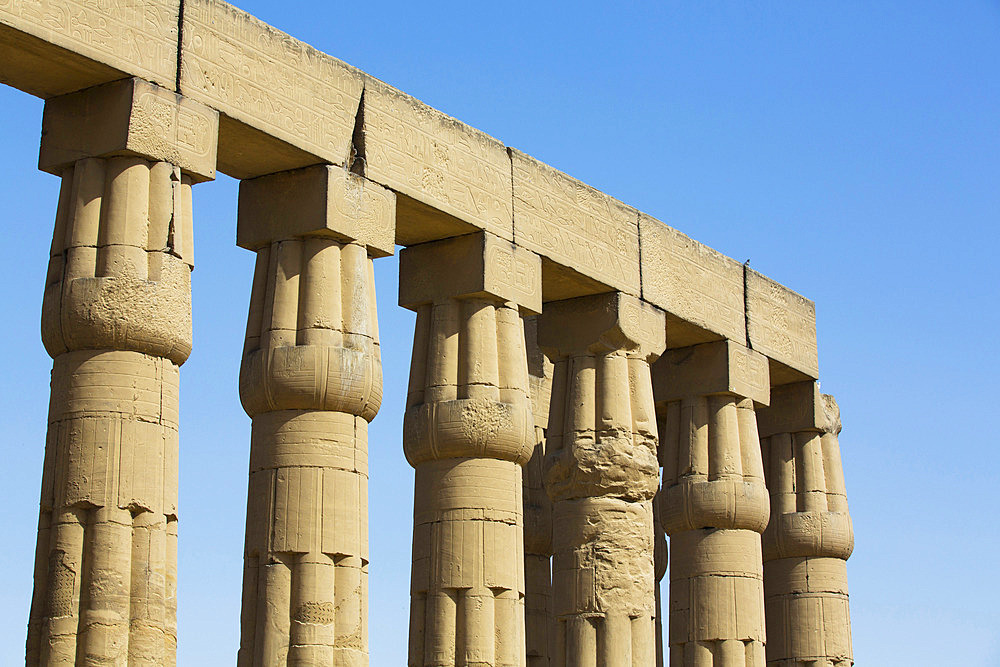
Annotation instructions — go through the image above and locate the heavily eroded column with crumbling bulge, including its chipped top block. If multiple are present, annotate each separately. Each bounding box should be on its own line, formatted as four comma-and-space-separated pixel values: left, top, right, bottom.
538, 293, 666, 667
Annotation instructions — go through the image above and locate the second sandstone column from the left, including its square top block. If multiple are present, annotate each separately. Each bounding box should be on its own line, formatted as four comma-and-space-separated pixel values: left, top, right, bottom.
237, 165, 395, 667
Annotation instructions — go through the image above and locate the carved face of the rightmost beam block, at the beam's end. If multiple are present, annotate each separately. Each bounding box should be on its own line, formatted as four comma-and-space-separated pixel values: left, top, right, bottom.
746, 269, 819, 378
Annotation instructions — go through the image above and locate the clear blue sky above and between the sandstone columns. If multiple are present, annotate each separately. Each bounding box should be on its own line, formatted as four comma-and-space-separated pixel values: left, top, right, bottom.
0, 0, 1000, 667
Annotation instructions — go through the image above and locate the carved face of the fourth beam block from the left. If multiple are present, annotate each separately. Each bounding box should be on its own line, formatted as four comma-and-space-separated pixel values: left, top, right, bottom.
511, 149, 639, 295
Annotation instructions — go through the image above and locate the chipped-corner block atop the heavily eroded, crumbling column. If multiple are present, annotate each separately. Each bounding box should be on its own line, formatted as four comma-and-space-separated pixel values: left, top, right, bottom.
538, 292, 666, 358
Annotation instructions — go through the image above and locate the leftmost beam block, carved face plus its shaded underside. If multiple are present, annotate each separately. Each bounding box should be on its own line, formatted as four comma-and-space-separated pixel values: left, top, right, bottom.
0, 0, 180, 99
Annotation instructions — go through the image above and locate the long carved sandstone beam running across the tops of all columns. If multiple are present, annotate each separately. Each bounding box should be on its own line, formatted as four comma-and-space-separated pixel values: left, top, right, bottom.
0, 0, 818, 376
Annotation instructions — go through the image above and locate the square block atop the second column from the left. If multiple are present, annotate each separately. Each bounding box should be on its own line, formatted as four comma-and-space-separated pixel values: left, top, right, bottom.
236, 165, 396, 257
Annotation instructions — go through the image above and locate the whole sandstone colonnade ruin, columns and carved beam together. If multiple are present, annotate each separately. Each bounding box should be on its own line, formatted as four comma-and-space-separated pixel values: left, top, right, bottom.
0, 0, 853, 667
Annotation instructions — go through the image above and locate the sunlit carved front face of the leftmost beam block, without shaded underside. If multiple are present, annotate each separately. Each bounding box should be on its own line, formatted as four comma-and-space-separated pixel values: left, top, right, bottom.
0, 0, 180, 88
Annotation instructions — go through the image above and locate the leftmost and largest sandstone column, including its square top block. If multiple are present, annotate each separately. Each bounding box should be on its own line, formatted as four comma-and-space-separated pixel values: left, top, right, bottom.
26, 79, 218, 666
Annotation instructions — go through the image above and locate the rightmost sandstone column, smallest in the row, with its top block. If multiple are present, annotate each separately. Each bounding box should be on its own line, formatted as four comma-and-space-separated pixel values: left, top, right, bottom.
759, 382, 854, 667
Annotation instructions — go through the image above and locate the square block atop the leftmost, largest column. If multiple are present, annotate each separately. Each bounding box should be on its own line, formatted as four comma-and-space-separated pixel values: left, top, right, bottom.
38, 78, 219, 182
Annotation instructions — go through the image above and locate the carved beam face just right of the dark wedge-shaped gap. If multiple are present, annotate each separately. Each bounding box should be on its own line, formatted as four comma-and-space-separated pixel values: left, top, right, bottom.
364, 78, 513, 241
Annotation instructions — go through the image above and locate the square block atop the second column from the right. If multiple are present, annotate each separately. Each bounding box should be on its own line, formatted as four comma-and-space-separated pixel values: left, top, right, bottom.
653, 340, 770, 406
